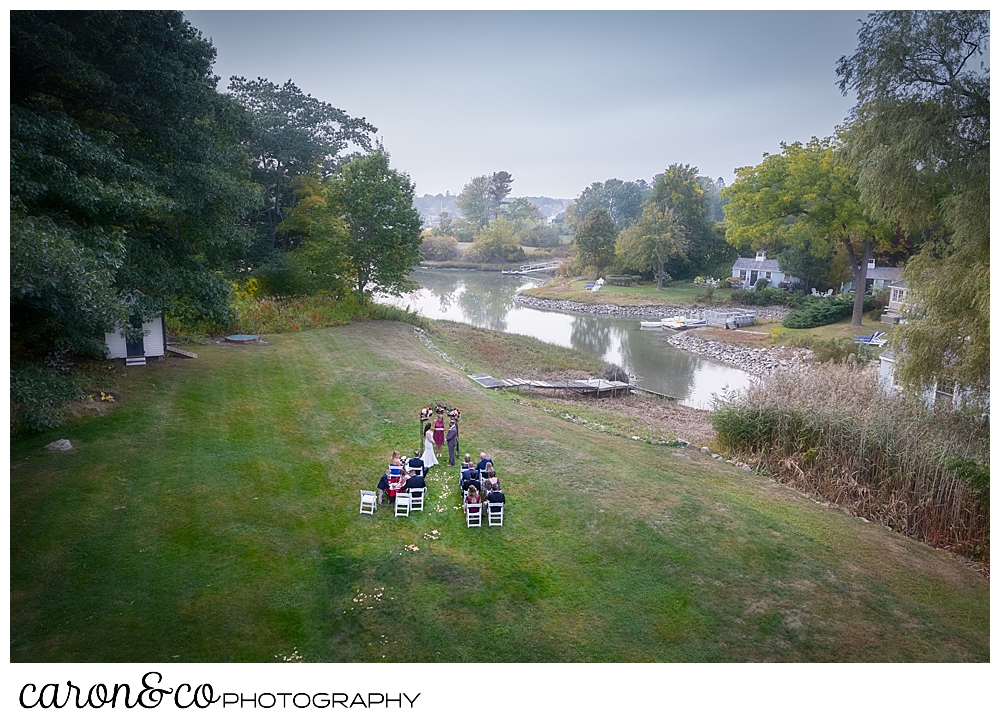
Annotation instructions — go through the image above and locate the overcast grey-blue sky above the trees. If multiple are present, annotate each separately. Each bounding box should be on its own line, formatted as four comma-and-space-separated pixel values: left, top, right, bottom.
185, 11, 865, 198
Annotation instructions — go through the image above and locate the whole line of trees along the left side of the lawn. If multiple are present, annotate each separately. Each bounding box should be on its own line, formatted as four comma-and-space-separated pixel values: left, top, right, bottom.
10, 11, 420, 430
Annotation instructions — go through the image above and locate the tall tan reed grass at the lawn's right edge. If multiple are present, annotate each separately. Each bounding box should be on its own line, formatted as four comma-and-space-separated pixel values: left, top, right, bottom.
712, 364, 990, 561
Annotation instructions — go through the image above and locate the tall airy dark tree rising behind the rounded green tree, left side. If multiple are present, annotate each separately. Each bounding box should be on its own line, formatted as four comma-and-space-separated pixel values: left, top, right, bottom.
229, 76, 377, 255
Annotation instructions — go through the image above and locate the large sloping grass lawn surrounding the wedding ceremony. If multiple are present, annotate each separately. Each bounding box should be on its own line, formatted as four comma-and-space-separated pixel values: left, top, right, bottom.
10, 322, 989, 662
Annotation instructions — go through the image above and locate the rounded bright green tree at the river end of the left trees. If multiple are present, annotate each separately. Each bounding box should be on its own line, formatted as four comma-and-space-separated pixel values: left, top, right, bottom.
326, 151, 421, 303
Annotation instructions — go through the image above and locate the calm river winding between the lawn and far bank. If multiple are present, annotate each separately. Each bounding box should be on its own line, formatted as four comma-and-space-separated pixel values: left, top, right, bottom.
380, 269, 750, 409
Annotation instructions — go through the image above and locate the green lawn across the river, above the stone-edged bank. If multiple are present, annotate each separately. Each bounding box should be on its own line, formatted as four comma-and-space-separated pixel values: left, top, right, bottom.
521, 278, 732, 306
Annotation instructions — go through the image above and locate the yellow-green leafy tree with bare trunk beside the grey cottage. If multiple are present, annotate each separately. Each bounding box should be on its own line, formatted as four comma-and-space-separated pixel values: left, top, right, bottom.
723, 138, 894, 326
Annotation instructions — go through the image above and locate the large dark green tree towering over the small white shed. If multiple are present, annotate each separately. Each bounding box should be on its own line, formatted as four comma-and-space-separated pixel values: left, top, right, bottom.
10, 11, 260, 359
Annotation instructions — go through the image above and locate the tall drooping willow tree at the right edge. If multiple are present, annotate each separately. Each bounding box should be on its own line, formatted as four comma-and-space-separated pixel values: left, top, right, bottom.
837, 11, 990, 391
